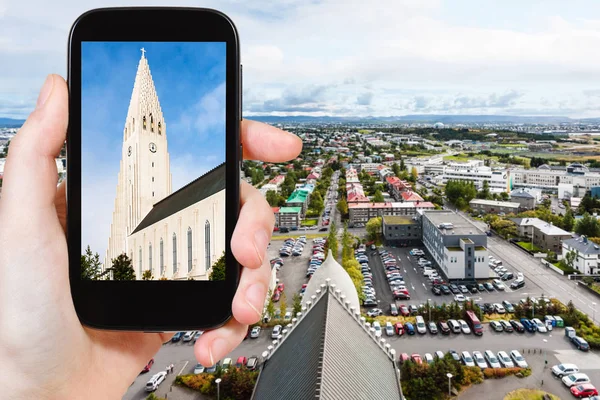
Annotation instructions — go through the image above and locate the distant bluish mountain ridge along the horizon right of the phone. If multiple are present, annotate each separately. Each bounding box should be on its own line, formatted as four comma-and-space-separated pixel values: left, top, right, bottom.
249, 114, 600, 124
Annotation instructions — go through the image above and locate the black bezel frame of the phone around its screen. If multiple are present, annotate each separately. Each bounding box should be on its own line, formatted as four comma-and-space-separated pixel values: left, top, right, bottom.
67, 7, 242, 332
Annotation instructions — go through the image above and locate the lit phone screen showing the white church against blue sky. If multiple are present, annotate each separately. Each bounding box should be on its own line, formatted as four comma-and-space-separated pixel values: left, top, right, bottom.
81, 41, 226, 281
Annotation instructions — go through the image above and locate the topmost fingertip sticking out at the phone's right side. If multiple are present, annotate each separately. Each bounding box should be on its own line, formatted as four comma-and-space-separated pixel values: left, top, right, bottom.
242, 119, 302, 162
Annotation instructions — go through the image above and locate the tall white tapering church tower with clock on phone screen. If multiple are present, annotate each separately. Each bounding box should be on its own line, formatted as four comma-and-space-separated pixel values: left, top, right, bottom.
104, 48, 171, 268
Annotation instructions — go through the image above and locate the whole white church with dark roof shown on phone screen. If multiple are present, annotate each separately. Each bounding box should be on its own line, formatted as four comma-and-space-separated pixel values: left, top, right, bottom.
104, 48, 225, 280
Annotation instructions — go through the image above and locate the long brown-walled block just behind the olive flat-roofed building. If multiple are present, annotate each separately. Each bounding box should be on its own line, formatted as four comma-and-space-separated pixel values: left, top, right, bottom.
348, 201, 435, 225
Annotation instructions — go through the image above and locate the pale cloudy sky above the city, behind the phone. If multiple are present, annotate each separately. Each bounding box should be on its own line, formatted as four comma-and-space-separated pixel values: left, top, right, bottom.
0, 0, 600, 118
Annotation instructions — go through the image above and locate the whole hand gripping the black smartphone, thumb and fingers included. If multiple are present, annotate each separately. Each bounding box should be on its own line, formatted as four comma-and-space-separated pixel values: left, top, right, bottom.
0, 75, 302, 400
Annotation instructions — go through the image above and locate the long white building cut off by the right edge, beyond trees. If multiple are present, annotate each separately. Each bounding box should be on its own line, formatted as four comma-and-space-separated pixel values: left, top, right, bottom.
510, 163, 600, 197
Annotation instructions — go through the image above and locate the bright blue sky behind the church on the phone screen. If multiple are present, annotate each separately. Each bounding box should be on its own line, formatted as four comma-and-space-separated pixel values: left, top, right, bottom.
81, 42, 226, 259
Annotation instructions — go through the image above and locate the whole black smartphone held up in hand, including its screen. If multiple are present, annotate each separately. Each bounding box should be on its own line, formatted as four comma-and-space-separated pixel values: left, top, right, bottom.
67, 7, 242, 332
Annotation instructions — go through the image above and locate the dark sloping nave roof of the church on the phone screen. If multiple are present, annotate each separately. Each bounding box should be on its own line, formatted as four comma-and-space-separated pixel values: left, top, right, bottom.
131, 163, 225, 234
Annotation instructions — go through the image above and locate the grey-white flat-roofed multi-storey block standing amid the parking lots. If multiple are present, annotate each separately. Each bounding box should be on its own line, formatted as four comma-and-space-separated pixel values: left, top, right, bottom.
421, 210, 490, 281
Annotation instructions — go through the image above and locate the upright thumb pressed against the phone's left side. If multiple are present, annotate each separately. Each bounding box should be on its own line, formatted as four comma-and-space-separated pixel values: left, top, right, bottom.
0, 75, 69, 219
